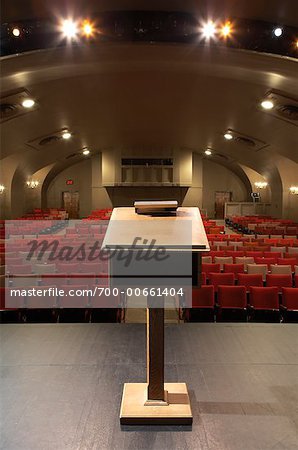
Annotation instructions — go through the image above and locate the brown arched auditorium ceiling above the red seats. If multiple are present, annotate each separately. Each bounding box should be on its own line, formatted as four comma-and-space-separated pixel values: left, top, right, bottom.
0, 0, 298, 193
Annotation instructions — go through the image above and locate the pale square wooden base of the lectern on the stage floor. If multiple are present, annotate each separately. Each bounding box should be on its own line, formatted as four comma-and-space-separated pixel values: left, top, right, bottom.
120, 383, 192, 425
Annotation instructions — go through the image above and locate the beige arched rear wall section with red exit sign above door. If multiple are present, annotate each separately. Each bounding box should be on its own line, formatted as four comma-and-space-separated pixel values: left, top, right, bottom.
47, 159, 91, 217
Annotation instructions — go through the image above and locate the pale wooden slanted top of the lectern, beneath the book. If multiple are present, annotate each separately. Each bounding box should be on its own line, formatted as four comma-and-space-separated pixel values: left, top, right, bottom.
102, 207, 209, 251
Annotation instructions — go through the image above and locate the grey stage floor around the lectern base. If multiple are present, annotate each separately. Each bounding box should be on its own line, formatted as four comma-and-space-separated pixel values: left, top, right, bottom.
0, 323, 298, 450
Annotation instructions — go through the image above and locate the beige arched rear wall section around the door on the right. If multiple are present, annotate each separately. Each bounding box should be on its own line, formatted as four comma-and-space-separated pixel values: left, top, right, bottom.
203, 159, 249, 217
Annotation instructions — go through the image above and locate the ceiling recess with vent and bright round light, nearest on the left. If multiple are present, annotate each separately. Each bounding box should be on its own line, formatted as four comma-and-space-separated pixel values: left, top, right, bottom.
0, 89, 37, 123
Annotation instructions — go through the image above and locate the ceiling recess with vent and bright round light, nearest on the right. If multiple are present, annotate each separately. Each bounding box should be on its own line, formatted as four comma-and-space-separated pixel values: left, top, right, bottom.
260, 90, 298, 127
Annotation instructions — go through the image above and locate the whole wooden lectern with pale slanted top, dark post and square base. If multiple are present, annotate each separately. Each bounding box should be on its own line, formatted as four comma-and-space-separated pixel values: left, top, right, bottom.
102, 208, 209, 425
